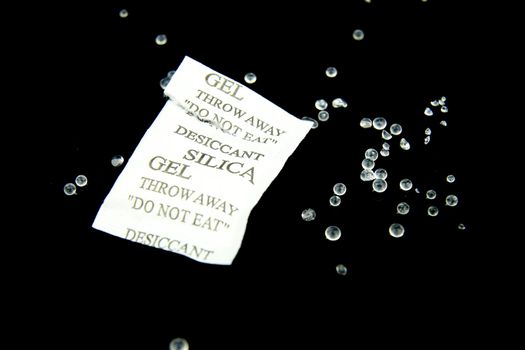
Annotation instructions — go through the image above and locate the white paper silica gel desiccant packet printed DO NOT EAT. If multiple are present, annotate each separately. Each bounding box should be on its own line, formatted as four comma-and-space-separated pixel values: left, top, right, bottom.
93, 57, 311, 265
